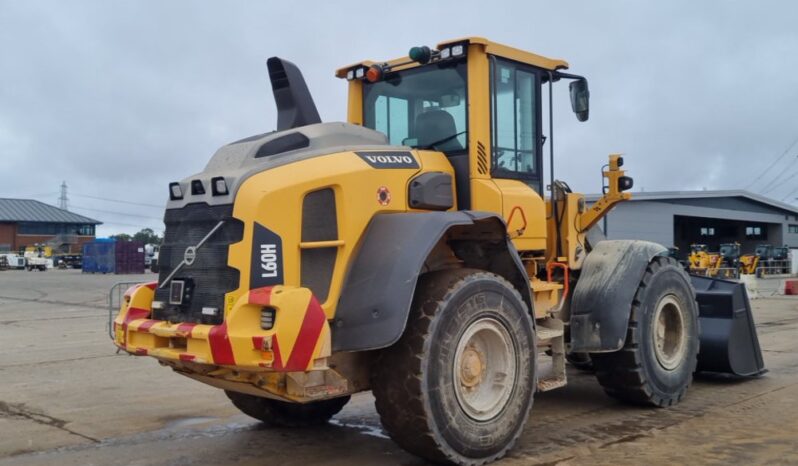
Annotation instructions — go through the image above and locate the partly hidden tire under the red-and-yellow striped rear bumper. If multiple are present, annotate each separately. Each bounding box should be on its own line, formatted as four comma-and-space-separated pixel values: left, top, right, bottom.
225, 390, 350, 427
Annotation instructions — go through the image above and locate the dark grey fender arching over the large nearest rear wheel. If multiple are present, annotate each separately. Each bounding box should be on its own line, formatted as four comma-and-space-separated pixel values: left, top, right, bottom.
332, 211, 532, 352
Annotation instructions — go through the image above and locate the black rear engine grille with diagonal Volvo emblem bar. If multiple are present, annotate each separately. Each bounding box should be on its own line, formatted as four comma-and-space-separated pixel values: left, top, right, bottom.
153, 203, 244, 325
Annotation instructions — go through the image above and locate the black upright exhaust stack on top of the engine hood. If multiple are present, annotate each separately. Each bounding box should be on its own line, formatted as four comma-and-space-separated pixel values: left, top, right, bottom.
266, 57, 321, 131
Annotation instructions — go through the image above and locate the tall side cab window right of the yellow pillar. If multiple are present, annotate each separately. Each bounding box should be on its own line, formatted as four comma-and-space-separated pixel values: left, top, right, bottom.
491, 57, 540, 186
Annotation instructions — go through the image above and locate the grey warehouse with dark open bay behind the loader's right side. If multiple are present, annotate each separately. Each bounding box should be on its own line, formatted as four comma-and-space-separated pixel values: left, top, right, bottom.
586, 190, 798, 258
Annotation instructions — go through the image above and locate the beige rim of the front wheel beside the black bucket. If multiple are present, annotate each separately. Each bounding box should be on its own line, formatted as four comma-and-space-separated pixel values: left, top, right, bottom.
652, 294, 687, 371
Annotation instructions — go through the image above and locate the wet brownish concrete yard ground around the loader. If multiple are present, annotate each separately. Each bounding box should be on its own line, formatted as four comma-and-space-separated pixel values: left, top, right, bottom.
0, 270, 798, 466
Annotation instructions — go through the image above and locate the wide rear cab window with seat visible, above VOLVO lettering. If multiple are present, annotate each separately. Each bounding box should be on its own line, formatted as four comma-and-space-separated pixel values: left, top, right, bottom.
363, 60, 468, 153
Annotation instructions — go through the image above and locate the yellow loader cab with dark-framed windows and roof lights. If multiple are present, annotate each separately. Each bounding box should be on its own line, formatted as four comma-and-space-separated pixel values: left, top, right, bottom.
336, 37, 587, 251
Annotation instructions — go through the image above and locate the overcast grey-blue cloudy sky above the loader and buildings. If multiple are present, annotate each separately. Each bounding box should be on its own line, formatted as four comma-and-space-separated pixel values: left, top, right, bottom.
0, 0, 798, 235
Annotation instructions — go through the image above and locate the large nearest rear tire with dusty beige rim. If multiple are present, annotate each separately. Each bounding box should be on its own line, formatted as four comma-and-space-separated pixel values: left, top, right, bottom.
371, 269, 536, 465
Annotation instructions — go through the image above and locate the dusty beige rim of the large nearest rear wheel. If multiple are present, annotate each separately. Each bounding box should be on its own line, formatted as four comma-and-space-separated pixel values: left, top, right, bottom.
453, 317, 517, 421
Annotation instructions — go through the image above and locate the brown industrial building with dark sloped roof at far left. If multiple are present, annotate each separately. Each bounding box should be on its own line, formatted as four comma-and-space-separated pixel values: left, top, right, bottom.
0, 198, 102, 253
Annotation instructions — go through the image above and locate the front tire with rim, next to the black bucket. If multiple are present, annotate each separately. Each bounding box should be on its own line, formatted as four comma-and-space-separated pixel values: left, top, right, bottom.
590, 257, 698, 407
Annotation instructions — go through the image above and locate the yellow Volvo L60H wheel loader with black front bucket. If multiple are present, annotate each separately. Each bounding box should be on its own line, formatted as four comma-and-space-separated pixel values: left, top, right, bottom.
112, 37, 764, 464
